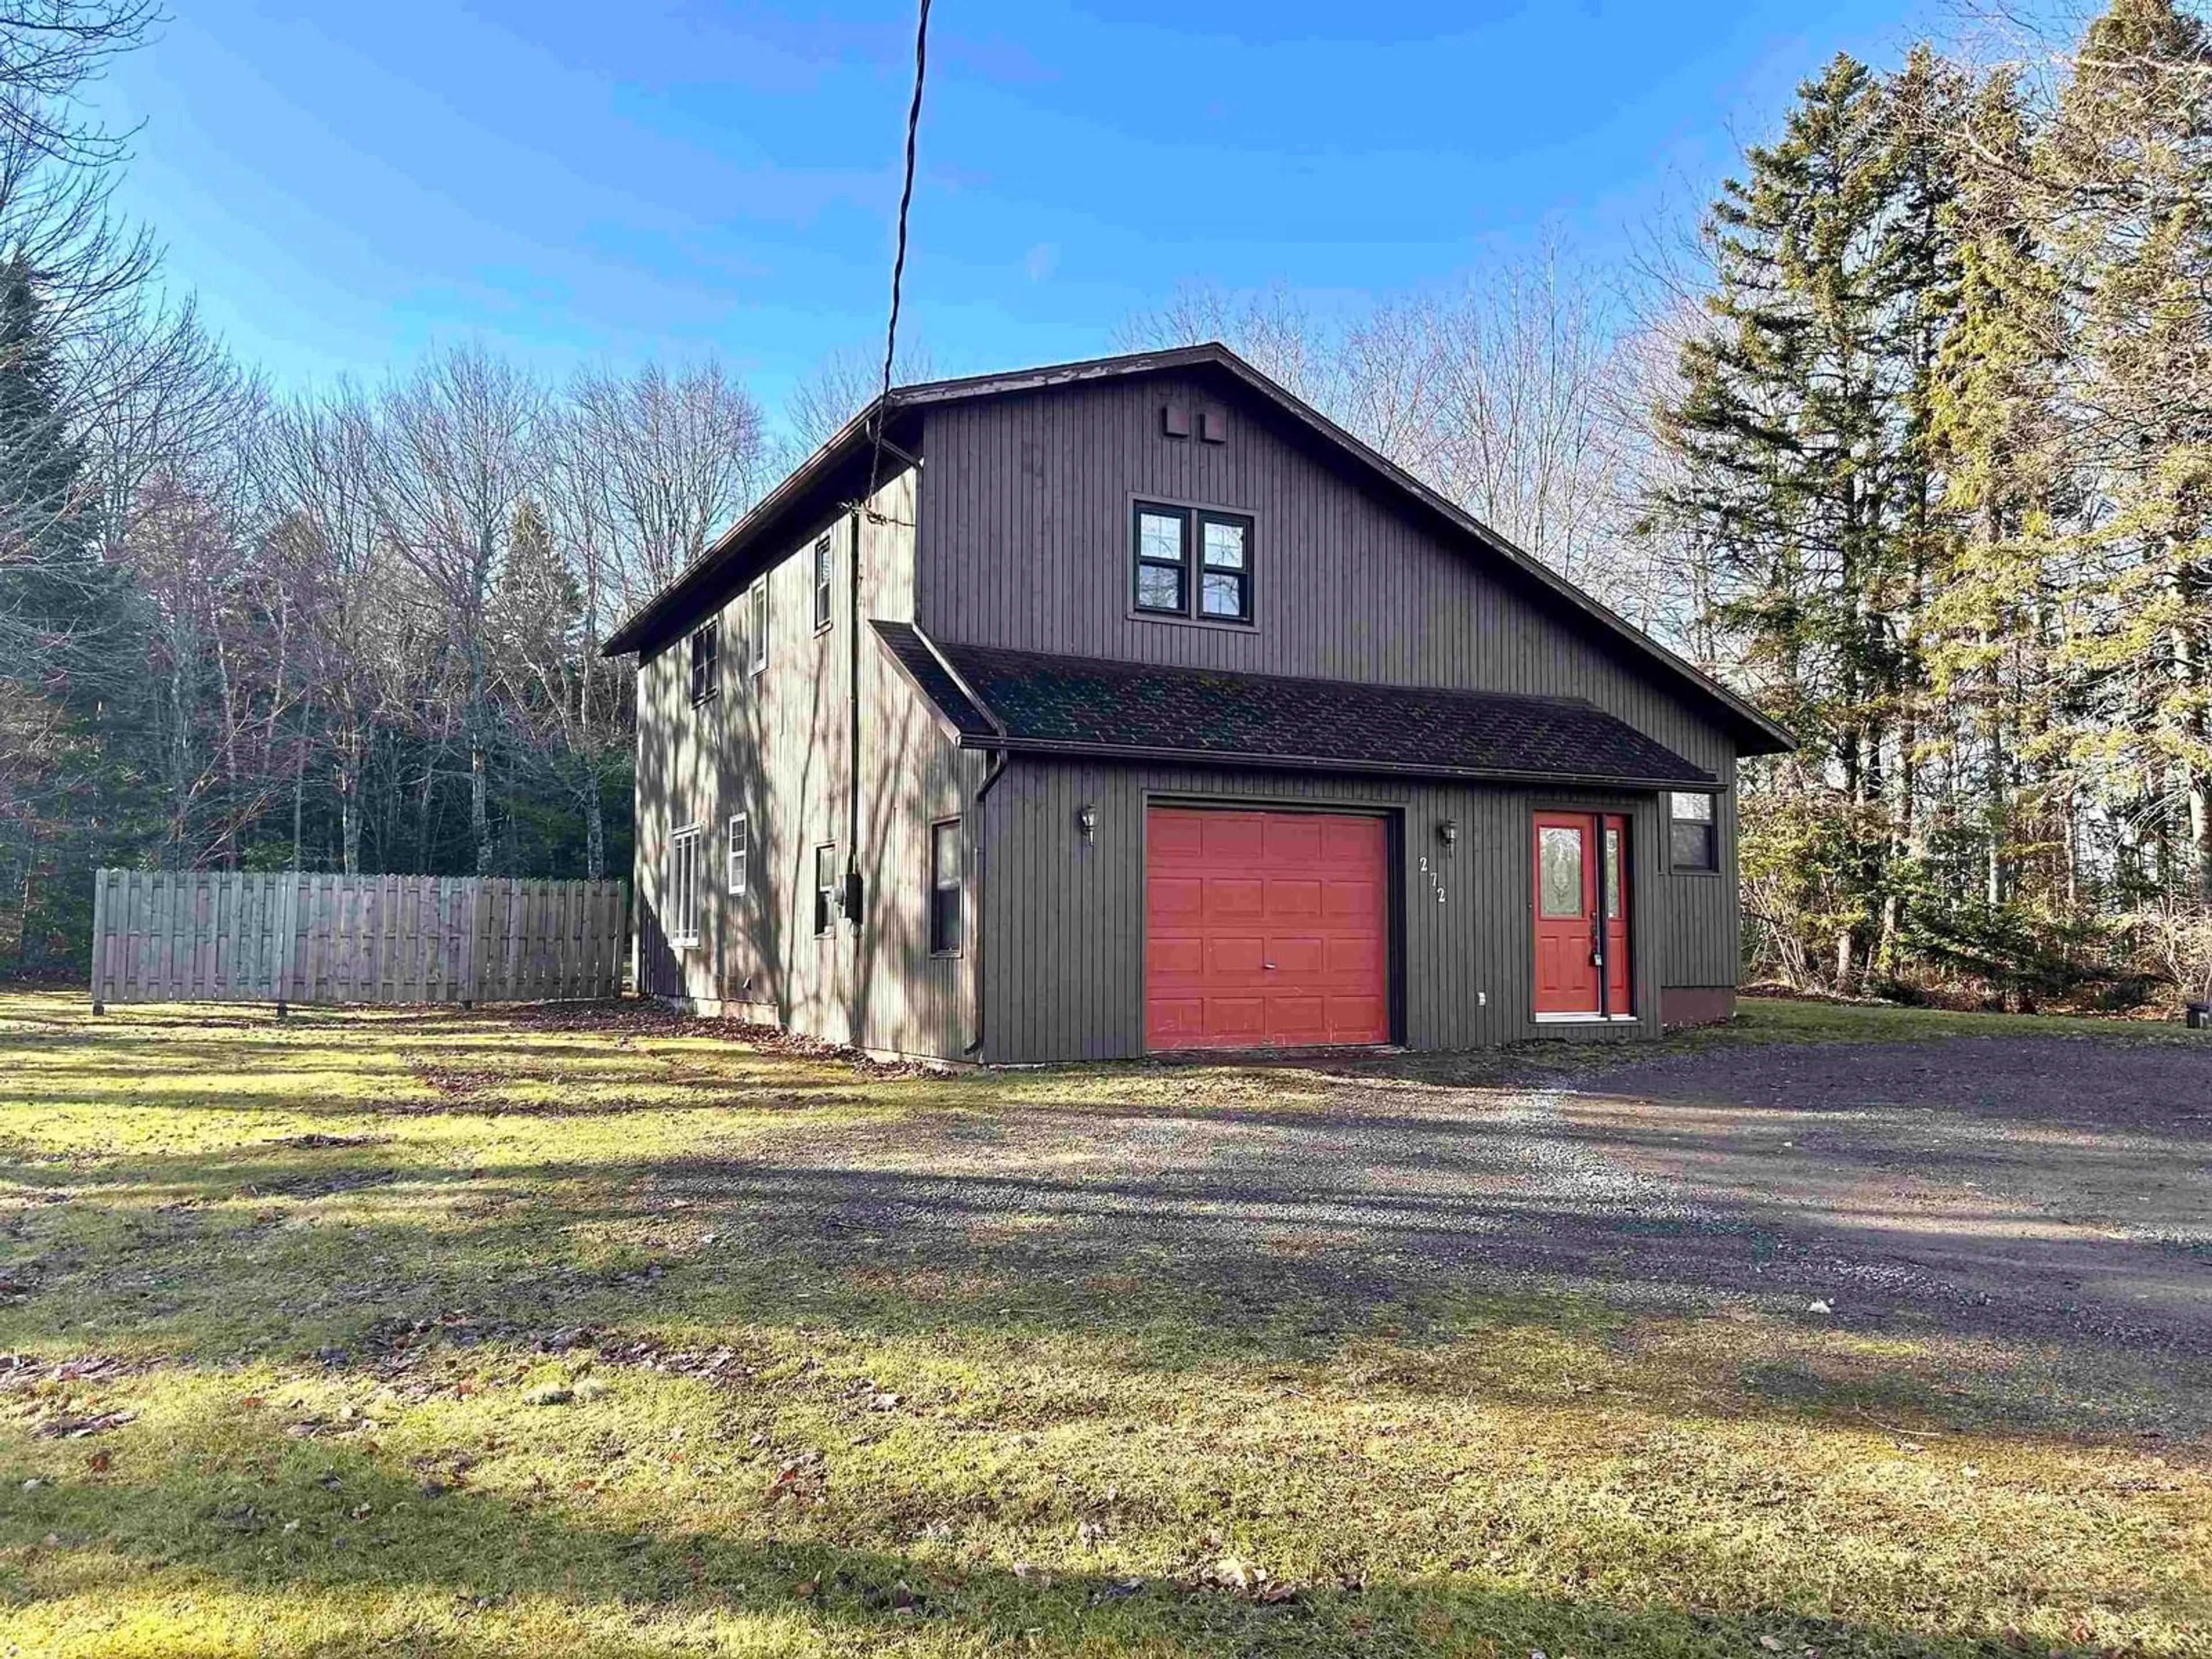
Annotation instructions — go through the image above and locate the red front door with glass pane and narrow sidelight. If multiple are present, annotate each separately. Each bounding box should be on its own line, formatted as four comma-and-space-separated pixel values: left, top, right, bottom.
1535, 812, 1635, 1017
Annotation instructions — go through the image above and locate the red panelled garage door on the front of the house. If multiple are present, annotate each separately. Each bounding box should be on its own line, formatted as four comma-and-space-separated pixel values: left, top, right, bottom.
1143, 808, 1389, 1048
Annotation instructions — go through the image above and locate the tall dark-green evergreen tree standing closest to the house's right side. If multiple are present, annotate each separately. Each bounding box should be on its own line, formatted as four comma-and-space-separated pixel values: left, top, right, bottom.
1659, 58, 1956, 980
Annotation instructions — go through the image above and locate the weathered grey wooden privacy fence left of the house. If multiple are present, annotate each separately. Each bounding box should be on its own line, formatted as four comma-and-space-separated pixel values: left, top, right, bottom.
93, 869, 626, 1011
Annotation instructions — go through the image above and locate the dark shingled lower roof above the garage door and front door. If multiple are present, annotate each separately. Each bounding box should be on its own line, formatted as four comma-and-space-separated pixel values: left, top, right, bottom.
876, 624, 1714, 787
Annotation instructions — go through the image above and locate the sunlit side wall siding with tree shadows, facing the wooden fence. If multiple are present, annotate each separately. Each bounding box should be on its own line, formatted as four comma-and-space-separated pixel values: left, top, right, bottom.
637, 469, 984, 1058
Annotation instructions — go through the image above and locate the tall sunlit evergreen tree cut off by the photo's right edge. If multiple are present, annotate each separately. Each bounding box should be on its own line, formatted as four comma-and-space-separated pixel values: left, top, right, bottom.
2035, 0, 2212, 898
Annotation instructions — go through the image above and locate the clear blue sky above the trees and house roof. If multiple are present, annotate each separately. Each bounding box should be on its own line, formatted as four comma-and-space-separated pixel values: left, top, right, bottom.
100, 0, 1973, 418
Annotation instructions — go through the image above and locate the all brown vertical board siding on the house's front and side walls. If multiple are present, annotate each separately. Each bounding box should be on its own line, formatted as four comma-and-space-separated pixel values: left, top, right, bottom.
623, 365, 1741, 1062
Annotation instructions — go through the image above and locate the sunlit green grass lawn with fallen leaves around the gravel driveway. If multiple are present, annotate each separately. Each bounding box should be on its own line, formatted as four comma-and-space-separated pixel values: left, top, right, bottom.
0, 993, 2212, 1659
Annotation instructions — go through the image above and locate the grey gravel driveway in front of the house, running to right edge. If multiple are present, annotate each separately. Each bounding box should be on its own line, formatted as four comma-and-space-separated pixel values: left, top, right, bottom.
703, 1037, 2212, 1369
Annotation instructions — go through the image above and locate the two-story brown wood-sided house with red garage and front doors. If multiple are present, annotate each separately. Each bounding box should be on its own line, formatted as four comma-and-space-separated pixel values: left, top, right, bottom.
606, 345, 1790, 1062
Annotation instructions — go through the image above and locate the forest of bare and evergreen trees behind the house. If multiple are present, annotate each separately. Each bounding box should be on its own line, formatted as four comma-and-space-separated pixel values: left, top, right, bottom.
0, 0, 2212, 1004
